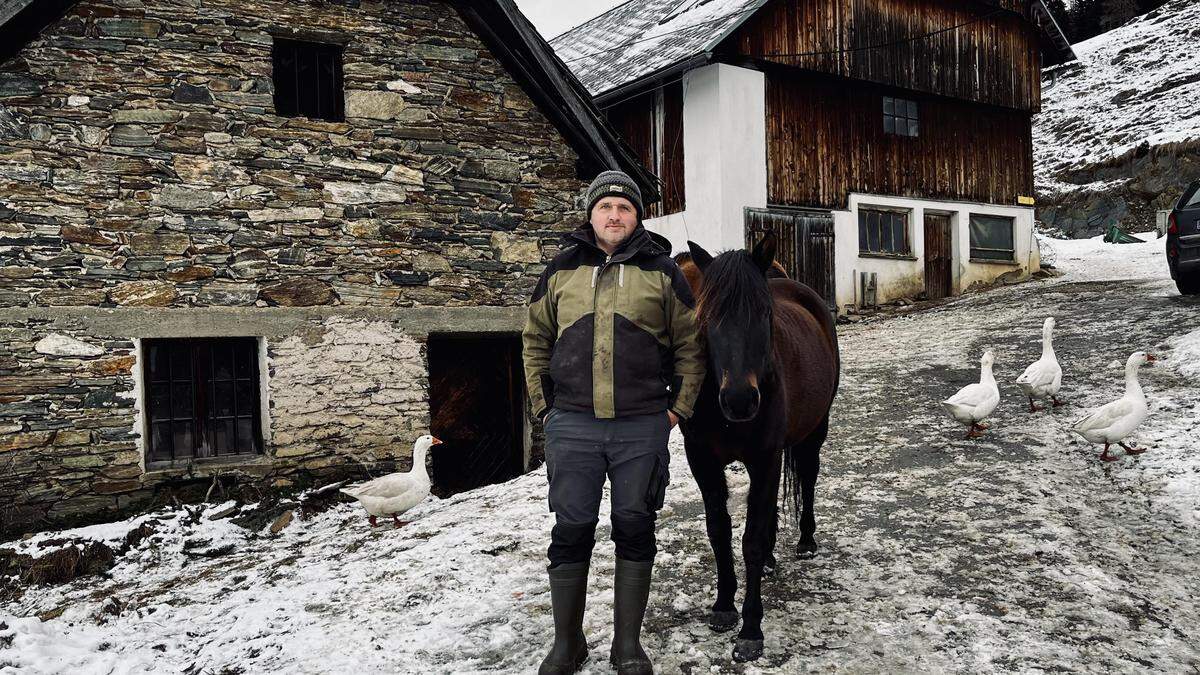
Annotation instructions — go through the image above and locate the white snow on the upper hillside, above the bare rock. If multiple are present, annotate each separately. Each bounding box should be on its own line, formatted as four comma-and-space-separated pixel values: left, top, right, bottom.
1033, 0, 1200, 193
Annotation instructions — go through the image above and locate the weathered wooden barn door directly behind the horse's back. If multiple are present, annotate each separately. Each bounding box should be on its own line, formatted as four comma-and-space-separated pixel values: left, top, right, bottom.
746, 209, 838, 311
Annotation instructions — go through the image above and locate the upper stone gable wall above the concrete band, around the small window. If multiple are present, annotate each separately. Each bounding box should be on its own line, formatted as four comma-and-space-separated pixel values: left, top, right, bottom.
0, 0, 581, 306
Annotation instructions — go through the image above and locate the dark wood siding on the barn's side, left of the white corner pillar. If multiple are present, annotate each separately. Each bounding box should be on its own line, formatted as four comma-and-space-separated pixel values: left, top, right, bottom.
605, 82, 685, 217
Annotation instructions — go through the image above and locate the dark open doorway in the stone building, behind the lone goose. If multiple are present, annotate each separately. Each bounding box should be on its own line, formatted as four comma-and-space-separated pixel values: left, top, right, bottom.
427, 335, 526, 497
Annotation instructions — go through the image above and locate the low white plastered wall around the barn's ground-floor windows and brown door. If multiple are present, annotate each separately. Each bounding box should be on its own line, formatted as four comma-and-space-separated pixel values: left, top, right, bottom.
833, 193, 1042, 311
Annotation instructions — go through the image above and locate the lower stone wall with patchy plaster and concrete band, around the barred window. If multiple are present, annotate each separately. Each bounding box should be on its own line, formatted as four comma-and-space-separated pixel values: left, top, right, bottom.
0, 306, 523, 532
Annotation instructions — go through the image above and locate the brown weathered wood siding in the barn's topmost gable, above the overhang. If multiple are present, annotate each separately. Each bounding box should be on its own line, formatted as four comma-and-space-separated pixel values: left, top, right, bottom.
726, 0, 1042, 112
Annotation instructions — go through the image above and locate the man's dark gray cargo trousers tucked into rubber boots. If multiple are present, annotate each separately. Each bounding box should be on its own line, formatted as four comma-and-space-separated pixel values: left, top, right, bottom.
545, 408, 671, 567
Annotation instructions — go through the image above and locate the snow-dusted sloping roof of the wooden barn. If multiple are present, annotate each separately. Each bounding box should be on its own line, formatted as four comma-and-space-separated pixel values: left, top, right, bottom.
550, 0, 767, 96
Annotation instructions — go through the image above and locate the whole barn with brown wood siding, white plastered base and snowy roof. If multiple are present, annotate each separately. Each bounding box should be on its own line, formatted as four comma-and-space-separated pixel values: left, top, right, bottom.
551, 0, 1073, 311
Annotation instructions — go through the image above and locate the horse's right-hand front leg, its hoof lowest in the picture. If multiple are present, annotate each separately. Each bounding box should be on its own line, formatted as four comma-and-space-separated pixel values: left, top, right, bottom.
733, 452, 784, 662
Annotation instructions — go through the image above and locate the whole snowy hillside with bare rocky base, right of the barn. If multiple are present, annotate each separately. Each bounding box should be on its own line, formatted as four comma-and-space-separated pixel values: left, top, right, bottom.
1033, 0, 1200, 237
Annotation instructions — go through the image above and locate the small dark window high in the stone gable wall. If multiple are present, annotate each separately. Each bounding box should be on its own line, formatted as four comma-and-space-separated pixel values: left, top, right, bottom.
271, 38, 346, 121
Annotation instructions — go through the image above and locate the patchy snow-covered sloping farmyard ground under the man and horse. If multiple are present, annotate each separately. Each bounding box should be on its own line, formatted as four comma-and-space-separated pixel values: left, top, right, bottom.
0, 240, 1200, 675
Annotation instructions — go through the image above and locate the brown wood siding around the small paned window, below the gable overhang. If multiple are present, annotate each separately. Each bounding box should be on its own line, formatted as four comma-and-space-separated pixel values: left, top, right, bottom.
767, 68, 1033, 208
